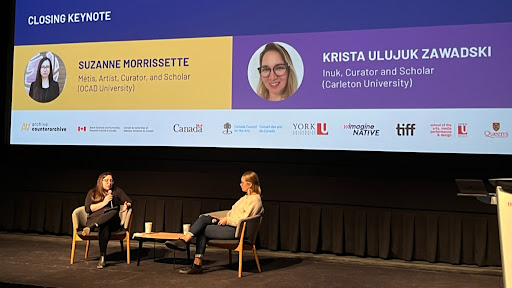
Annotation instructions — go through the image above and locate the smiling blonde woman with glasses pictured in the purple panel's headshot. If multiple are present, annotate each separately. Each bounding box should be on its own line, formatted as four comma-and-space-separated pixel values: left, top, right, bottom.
257, 42, 298, 101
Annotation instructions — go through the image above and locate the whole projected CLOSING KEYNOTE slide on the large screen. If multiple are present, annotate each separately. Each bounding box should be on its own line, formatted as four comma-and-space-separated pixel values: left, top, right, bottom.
10, 0, 512, 154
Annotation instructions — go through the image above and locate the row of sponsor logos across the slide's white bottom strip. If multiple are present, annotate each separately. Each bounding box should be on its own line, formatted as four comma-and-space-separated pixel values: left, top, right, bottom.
13, 122, 509, 138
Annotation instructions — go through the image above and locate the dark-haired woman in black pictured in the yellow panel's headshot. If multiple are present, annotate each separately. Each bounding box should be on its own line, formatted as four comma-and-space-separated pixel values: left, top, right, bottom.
28, 57, 60, 103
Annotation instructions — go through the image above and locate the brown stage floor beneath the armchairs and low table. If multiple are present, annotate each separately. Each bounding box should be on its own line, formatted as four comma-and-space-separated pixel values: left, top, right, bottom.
0, 232, 503, 288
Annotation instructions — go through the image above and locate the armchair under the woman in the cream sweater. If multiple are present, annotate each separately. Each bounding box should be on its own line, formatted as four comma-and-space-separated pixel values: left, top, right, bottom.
207, 209, 263, 277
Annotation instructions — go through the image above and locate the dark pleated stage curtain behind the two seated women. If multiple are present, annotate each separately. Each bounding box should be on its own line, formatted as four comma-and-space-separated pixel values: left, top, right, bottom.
0, 192, 501, 266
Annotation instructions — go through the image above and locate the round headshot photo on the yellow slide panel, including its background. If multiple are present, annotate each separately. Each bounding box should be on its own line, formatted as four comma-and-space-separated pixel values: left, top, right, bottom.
25, 52, 66, 103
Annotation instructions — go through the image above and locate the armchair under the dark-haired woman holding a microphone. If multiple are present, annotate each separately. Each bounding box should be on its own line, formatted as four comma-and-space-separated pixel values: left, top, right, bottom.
70, 205, 133, 264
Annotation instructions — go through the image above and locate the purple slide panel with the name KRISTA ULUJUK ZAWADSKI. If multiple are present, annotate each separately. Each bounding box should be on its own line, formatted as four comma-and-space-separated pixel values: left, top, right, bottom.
232, 23, 512, 109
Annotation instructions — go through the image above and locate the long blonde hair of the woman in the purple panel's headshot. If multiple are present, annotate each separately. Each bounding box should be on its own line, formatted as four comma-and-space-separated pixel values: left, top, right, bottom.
257, 42, 298, 99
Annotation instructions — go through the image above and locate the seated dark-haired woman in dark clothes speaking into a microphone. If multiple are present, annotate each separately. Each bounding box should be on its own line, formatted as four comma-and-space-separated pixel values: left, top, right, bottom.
82, 172, 132, 269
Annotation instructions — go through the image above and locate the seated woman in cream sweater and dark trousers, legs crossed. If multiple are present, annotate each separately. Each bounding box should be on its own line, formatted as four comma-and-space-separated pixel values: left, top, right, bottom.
165, 171, 263, 274
